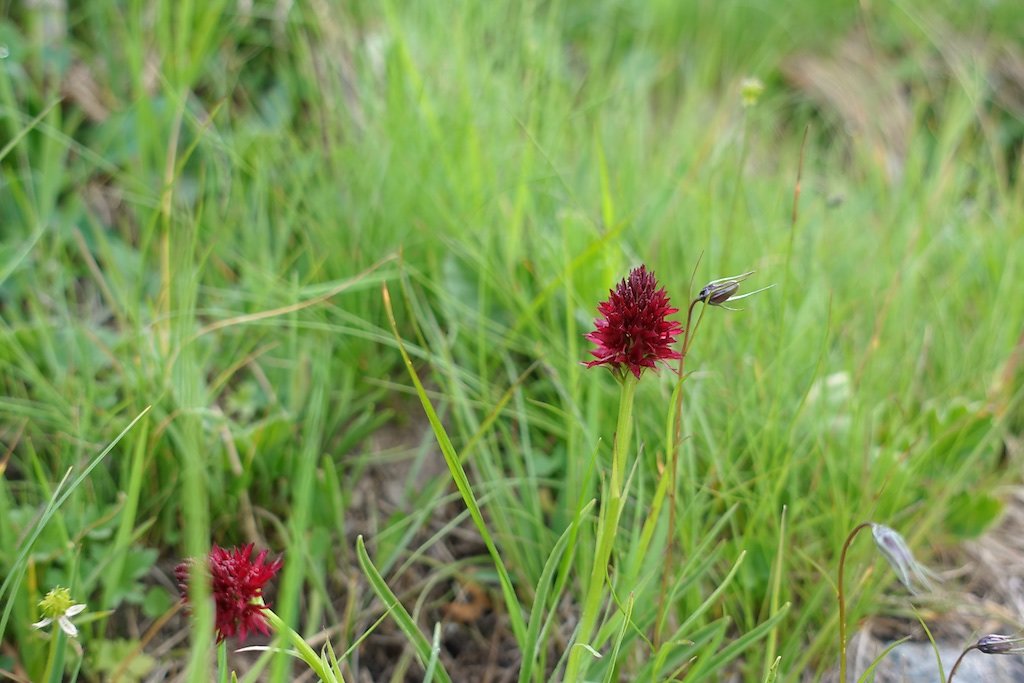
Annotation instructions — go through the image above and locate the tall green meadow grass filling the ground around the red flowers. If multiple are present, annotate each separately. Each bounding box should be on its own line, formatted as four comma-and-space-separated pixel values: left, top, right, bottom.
0, 0, 1024, 681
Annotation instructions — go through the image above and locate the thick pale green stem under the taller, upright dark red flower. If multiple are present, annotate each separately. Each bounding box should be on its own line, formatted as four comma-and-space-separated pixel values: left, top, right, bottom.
564, 372, 639, 681
